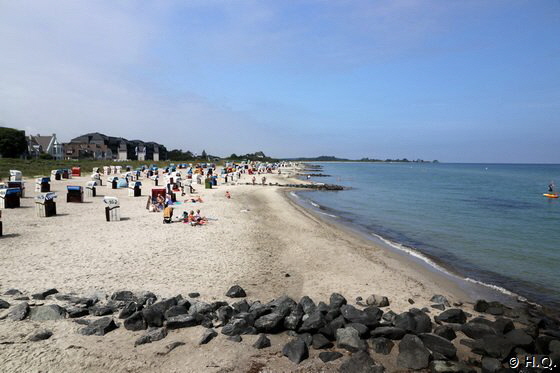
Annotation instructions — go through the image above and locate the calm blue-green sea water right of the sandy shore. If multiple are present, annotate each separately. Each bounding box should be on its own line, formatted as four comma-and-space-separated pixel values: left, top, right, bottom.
299, 163, 560, 310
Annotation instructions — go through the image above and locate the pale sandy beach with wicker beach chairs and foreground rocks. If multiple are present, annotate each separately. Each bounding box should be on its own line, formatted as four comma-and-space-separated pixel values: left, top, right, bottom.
0, 169, 540, 372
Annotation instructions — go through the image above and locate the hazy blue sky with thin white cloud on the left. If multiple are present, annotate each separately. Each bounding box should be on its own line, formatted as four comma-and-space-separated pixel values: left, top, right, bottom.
0, 0, 560, 163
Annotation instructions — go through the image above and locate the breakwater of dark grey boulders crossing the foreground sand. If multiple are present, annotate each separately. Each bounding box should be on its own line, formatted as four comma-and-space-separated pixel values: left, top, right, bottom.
0, 285, 560, 372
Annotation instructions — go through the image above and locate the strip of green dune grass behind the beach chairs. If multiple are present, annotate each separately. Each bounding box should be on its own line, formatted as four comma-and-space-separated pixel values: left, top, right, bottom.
0, 158, 223, 180
